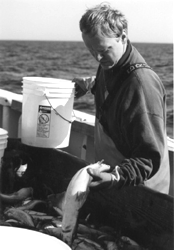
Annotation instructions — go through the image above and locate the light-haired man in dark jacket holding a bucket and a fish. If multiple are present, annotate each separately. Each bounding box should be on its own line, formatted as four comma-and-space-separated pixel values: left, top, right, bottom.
73, 4, 169, 194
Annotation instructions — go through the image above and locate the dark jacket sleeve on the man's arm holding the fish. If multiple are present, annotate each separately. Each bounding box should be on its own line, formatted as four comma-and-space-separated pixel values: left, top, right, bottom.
113, 70, 166, 186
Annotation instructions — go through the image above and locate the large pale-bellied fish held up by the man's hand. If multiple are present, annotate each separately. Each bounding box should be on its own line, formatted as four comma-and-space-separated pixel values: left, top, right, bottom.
62, 161, 108, 246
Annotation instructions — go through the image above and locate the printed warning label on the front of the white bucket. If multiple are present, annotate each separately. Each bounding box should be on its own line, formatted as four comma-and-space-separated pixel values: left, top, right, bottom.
36, 105, 51, 138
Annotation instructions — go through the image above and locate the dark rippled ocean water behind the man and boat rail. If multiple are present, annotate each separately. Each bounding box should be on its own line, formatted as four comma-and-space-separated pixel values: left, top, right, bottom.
0, 41, 174, 138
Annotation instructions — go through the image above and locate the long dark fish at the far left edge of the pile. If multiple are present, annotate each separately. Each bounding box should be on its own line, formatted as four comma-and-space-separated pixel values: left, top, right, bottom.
0, 187, 33, 205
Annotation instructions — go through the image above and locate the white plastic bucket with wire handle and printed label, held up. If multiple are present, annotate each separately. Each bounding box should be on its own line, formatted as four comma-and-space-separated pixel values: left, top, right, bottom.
21, 77, 74, 148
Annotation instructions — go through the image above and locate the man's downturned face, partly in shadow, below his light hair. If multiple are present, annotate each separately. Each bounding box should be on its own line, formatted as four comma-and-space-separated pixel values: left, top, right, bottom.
82, 33, 125, 70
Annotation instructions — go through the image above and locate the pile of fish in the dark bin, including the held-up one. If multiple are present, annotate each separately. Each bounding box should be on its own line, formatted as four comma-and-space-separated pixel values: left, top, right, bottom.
0, 164, 147, 250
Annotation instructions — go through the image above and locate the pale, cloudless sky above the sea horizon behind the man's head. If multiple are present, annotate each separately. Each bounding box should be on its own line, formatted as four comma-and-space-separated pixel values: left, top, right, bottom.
0, 0, 174, 43
